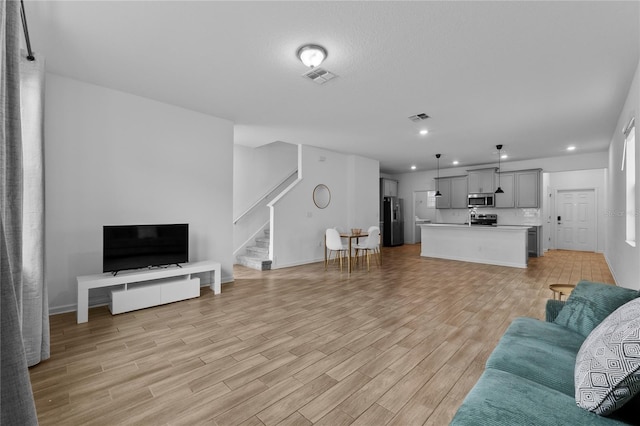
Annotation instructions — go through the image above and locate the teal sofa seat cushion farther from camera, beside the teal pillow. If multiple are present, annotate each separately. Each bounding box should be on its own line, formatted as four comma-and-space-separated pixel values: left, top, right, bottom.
486, 318, 584, 397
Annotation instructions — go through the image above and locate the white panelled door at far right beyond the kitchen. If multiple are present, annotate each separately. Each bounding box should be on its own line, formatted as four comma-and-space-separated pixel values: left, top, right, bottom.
556, 189, 596, 251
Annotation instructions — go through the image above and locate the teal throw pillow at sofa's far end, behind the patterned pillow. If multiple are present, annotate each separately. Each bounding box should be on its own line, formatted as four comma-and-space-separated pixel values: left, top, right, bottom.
554, 281, 638, 337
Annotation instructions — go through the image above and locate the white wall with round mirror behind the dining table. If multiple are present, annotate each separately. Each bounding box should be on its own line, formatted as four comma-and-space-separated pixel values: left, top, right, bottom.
271, 146, 380, 269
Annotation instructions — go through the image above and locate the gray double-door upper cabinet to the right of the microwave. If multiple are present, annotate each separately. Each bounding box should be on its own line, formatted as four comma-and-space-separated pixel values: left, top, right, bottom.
495, 169, 541, 208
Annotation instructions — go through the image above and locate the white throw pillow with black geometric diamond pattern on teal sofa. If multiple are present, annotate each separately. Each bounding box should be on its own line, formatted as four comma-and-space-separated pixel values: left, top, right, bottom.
574, 299, 640, 415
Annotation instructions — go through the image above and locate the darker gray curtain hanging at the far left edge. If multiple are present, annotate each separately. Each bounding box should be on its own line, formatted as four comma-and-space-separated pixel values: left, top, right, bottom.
0, 0, 48, 425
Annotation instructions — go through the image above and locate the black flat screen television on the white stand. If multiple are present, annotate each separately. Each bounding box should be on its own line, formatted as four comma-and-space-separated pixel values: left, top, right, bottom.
102, 223, 189, 274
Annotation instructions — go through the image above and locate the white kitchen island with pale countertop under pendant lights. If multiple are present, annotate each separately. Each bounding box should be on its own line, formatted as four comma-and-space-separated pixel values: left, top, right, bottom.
420, 223, 529, 268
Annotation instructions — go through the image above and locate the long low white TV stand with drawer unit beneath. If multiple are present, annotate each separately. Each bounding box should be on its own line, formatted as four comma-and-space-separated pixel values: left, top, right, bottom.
77, 260, 222, 324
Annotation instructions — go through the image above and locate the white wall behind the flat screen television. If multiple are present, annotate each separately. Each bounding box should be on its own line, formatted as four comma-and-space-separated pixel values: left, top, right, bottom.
45, 74, 233, 313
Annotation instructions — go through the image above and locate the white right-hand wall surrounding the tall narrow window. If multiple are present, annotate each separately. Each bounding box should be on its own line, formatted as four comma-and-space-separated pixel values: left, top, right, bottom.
605, 57, 640, 289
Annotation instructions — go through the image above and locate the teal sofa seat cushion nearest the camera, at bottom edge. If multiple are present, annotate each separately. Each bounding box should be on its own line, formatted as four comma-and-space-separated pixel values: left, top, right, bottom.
450, 368, 626, 426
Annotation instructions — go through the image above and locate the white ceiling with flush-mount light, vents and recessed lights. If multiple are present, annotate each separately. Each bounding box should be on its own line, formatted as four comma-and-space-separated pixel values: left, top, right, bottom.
25, 0, 640, 173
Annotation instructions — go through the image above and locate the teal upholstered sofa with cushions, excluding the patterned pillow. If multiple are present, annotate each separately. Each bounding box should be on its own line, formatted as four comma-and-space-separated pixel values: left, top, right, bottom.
451, 281, 640, 426
